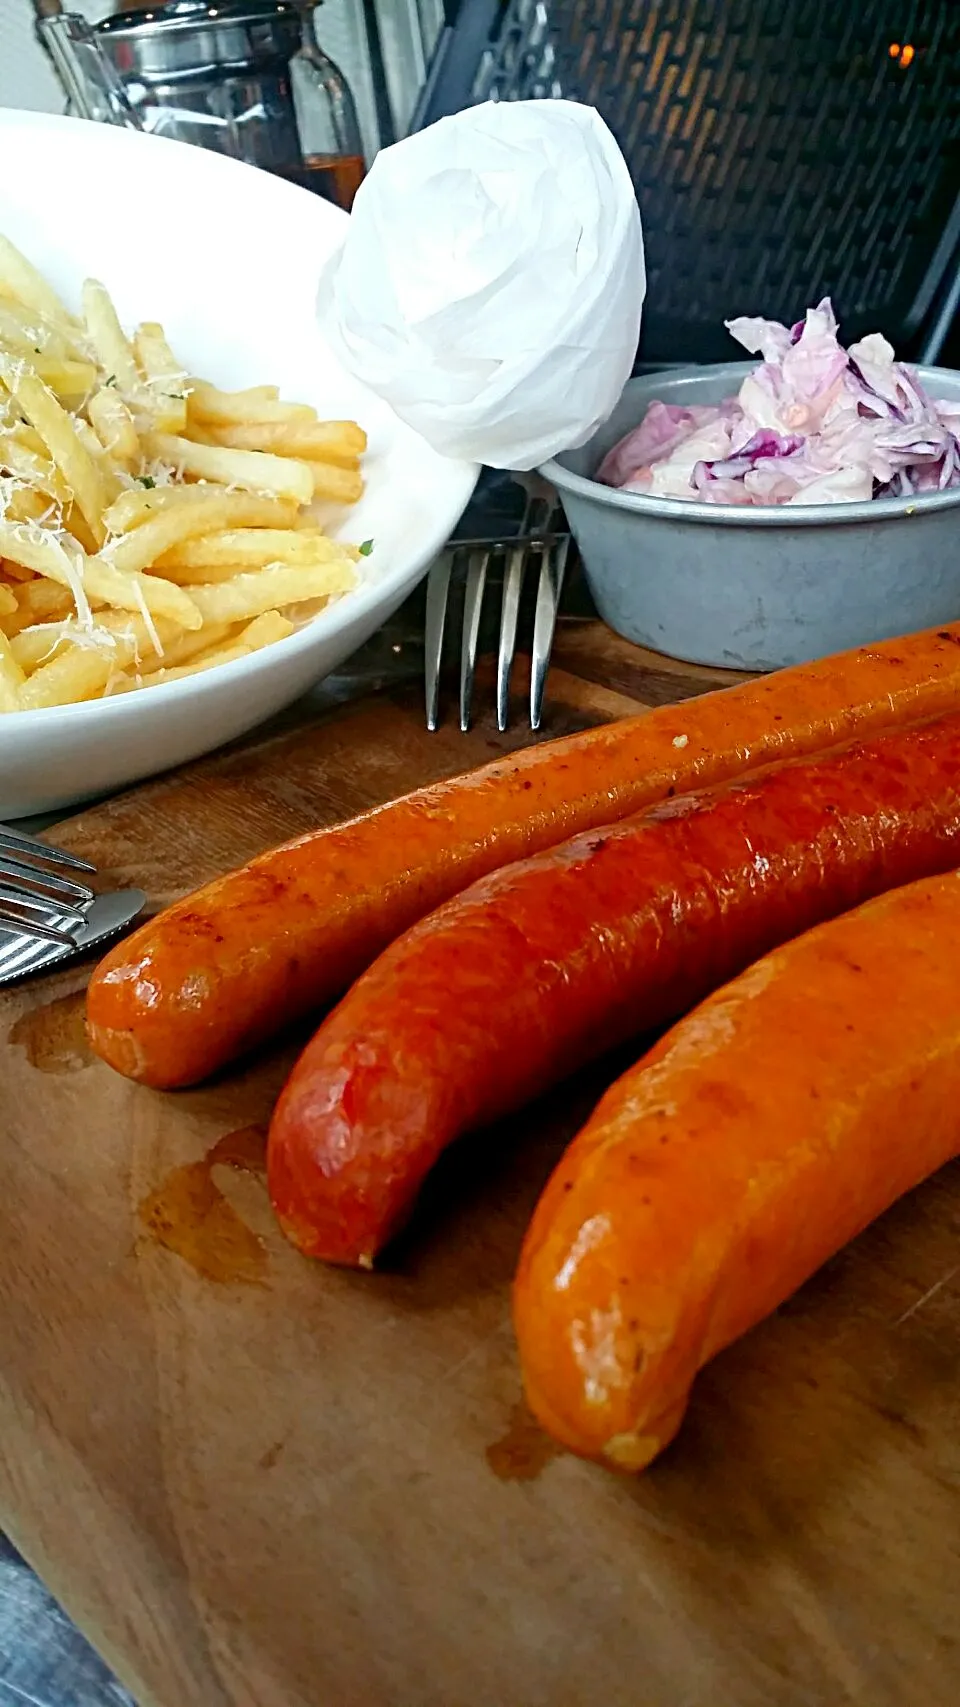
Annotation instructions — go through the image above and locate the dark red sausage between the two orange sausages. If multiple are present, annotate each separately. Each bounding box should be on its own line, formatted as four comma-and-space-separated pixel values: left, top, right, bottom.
268, 715, 960, 1267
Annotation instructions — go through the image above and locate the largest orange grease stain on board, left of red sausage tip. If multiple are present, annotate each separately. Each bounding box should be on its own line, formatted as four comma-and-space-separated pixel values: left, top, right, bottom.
138, 1127, 266, 1285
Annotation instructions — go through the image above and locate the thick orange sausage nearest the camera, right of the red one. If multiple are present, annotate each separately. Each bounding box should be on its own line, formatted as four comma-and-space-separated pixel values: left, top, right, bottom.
514, 872, 960, 1470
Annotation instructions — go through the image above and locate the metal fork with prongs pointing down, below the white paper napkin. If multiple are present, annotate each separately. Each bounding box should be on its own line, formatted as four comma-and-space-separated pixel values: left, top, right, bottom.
424, 485, 571, 732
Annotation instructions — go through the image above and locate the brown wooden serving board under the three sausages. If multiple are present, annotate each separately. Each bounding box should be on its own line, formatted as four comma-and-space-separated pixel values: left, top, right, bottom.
0, 625, 960, 1707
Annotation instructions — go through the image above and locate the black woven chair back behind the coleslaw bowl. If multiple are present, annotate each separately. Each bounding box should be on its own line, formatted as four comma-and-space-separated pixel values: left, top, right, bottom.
473, 0, 960, 360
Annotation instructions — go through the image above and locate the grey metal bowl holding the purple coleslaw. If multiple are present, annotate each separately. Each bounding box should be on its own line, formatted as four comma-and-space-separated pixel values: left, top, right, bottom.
540, 362, 960, 669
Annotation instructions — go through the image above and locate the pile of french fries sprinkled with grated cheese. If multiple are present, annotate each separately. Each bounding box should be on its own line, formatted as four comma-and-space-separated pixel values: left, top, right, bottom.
0, 237, 366, 712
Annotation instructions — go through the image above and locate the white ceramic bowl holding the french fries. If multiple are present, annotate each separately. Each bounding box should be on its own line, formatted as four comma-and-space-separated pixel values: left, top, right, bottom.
0, 111, 477, 819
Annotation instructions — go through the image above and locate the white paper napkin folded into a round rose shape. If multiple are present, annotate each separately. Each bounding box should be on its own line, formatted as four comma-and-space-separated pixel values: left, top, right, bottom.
318, 101, 646, 469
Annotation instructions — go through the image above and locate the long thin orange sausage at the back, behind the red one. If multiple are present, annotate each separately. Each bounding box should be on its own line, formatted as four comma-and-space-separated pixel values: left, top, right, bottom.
87, 623, 960, 1089
